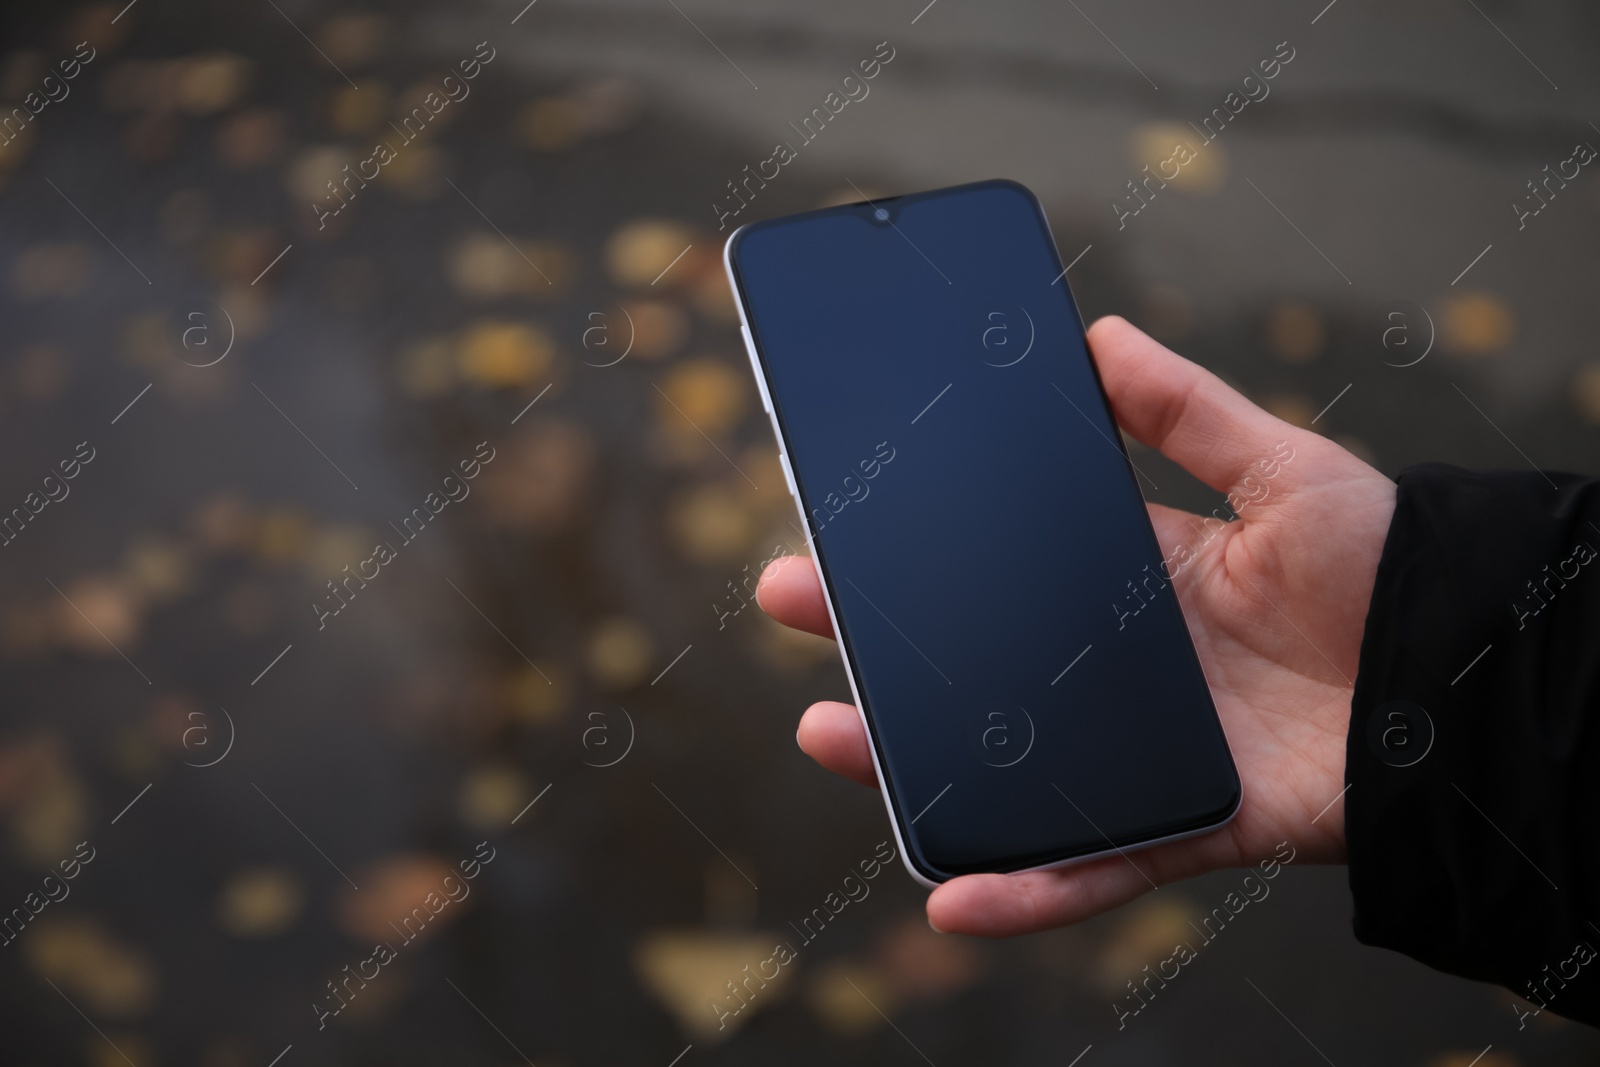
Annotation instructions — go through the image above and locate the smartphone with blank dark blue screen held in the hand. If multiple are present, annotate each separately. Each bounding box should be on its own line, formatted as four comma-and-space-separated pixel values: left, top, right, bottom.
723, 181, 1242, 888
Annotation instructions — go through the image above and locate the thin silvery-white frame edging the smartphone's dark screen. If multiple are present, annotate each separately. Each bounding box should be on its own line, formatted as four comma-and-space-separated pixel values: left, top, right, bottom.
722, 192, 1245, 889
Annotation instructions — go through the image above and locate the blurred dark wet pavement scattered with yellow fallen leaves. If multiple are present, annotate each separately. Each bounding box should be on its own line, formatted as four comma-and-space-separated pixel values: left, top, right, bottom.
0, 0, 1600, 1067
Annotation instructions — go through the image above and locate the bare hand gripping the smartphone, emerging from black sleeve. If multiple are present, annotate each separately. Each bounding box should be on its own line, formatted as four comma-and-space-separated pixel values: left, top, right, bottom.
758, 318, 1395, 937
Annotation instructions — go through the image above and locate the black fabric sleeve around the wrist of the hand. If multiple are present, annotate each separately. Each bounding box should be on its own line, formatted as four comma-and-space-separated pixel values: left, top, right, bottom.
1344, 464, 1600, 1024
